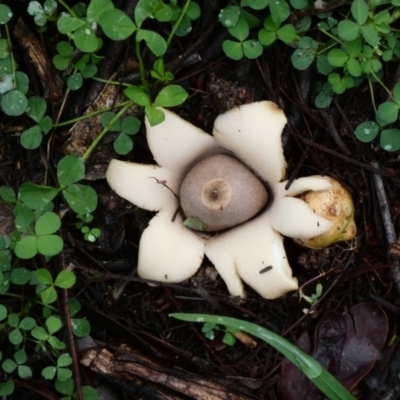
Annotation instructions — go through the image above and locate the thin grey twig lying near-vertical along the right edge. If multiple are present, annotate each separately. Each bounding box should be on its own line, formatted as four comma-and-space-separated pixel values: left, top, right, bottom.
371, 162, 400, 293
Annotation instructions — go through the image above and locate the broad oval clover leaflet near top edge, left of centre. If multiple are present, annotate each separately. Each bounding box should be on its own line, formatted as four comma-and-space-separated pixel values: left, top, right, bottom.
99, 9, 135, 40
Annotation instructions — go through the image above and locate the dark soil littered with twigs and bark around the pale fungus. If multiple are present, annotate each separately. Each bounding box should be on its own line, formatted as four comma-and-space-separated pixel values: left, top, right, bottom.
0, 0, 400, 400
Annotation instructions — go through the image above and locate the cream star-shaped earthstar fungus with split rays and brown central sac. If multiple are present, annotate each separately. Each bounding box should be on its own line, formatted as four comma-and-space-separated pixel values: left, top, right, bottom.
106, 101, 356, 299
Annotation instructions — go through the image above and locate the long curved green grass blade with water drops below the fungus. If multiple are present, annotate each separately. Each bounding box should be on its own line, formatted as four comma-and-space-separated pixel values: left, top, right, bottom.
170, 314, 355, 400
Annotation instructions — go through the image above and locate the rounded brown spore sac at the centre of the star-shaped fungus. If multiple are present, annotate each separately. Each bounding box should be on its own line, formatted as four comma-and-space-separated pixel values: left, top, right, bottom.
179, 154, 268, 231
